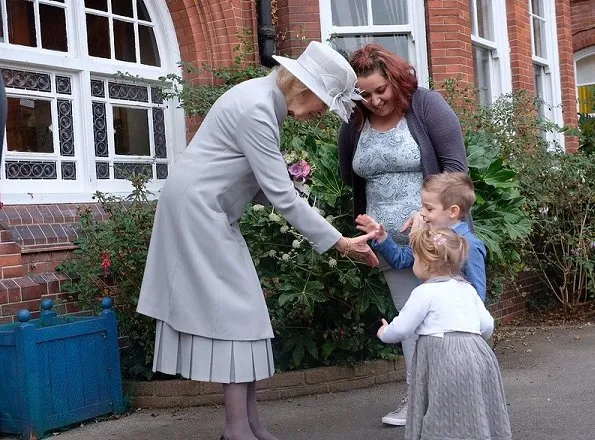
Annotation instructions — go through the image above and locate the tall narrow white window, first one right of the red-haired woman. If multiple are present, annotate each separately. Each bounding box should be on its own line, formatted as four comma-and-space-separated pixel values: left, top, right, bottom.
469, 0, 512, 105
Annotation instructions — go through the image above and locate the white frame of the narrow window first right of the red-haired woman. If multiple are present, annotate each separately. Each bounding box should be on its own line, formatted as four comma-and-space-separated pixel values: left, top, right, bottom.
470, 0, 512, 105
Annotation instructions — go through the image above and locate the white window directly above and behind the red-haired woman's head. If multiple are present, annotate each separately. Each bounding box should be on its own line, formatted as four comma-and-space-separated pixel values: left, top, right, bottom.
320, 0, 428, 84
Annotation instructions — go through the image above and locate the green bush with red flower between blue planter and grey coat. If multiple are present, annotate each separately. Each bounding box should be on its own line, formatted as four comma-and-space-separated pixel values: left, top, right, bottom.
59, 175, 155, 379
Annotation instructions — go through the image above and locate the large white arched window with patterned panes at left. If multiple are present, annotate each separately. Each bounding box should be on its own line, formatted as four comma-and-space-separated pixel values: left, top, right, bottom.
0, 0, 185, 203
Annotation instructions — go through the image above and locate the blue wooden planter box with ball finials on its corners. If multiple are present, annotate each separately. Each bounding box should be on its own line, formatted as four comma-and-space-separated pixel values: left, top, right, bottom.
0, 298, 124, 439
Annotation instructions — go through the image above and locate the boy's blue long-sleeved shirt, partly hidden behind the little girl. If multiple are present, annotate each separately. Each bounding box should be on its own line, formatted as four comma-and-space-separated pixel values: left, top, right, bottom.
372, 222, 487, 301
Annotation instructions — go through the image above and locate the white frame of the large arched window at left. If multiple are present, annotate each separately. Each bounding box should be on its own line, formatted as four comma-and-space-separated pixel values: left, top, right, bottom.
0, 0, 186, 204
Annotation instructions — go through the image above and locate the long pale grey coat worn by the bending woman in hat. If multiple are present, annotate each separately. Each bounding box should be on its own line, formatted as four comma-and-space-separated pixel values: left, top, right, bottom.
137, 73, 341, 341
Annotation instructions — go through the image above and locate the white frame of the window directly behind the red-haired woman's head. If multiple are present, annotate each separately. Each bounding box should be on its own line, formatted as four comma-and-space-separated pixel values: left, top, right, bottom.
319, 0, 430, 87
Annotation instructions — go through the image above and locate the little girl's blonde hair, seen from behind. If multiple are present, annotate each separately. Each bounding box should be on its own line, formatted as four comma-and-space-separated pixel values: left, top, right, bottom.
411, 228, 469, 276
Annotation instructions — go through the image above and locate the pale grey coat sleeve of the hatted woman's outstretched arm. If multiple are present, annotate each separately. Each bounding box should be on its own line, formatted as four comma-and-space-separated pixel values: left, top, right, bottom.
236, 106, 341, 253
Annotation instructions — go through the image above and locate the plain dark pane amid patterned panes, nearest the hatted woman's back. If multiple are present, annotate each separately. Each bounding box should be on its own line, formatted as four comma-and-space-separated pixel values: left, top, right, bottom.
113, 106, 151, 156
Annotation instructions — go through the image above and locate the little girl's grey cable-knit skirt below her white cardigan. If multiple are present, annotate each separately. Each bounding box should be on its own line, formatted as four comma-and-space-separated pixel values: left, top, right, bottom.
405, 332, 512, 440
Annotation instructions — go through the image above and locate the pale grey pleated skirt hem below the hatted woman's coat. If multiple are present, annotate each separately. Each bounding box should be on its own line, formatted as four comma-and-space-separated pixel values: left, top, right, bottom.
153, 320, 275, 383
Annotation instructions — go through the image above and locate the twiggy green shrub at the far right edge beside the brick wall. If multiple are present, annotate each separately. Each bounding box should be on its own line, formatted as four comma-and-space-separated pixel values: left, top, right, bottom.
523, 152, 595, 310
